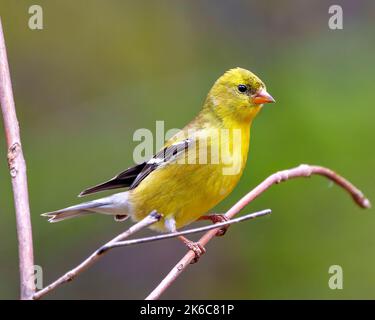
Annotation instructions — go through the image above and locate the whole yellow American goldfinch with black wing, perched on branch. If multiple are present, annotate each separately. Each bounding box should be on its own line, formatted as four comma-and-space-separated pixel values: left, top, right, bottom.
43, 68, 275, 256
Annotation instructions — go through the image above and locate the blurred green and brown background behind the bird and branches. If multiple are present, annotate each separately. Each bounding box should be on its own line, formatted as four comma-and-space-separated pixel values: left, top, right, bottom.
0, 0, 375, 299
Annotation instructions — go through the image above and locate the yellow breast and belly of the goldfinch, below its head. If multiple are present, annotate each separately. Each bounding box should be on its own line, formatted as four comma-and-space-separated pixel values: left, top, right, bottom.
129, 125, 250, 231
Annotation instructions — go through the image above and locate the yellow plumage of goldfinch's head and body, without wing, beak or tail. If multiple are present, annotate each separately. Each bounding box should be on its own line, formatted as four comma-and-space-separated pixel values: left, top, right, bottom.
129, 68, 272, 231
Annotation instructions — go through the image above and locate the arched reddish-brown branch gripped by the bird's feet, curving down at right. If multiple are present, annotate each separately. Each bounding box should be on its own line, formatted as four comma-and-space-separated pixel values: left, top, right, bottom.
146, 164, 371, 300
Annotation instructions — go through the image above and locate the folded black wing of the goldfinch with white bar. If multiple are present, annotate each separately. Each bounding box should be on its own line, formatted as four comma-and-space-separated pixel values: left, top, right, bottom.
79, 139, 193, 197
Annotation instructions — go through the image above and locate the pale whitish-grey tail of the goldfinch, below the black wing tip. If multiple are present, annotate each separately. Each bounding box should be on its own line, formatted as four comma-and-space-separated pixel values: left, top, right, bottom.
42, 192, 130, 222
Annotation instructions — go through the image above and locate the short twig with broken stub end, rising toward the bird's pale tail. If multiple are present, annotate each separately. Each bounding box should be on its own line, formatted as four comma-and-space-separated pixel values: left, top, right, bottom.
32, 211, 161, 300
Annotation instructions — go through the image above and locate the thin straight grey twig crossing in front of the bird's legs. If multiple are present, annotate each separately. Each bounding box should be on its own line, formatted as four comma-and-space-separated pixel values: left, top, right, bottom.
107, 209, 271, 250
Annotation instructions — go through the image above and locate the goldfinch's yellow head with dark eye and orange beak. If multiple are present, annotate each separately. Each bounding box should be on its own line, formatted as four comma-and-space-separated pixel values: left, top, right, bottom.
206, 68, 275, 122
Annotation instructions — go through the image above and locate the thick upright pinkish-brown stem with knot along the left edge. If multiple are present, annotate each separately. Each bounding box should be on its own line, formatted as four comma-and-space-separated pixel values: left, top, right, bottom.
0, 19, 35, 299
